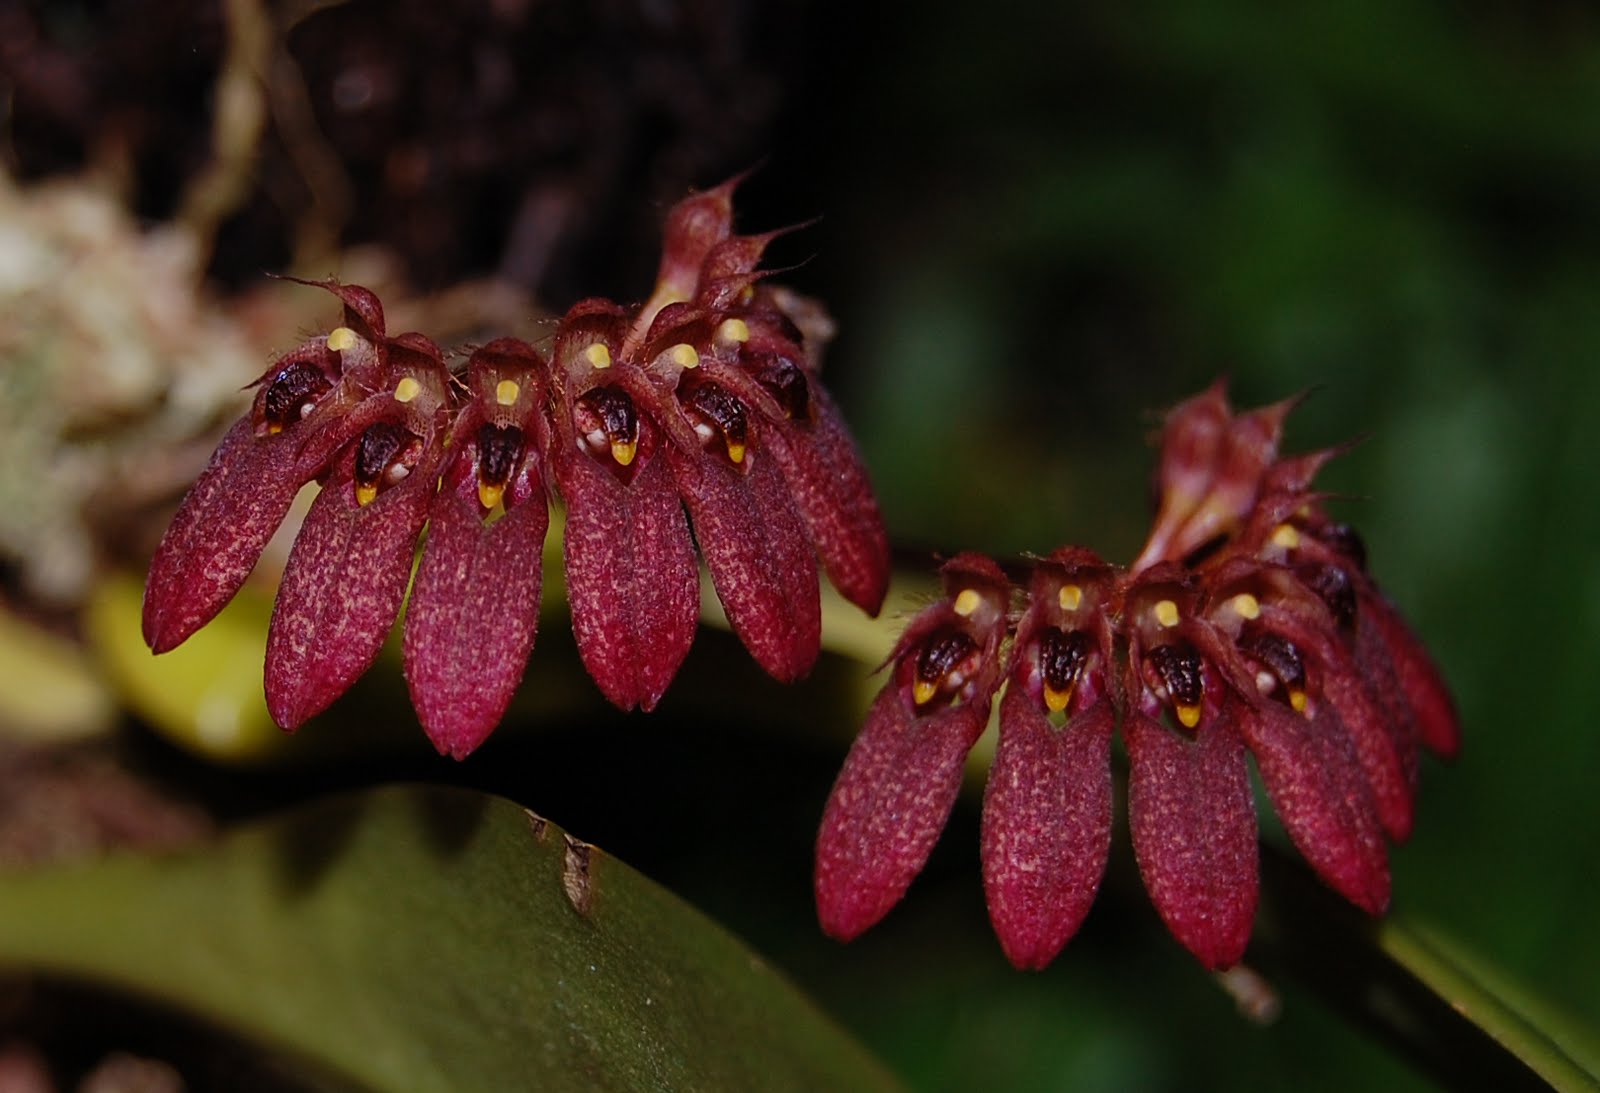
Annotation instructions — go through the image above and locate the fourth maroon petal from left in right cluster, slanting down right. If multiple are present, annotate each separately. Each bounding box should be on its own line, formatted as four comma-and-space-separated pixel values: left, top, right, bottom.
1232, 699, 1389, 915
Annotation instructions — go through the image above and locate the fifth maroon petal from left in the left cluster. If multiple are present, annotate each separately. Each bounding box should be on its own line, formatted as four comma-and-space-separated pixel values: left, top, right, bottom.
667, 409, 822, 683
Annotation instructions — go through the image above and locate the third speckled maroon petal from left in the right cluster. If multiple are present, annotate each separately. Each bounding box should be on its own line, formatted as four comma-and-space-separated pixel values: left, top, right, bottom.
1123, 711, 1259, 970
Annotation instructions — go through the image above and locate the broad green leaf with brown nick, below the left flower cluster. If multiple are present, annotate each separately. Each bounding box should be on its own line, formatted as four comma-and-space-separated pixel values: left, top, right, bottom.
0, 787, 896, 1091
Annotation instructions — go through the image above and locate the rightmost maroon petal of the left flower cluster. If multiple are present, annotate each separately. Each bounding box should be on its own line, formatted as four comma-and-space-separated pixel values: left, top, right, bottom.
768, 384, 890, 615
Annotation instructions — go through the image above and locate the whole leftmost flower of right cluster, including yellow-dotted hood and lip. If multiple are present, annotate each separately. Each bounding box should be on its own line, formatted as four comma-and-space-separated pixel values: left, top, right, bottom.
816, 554, 1010, 941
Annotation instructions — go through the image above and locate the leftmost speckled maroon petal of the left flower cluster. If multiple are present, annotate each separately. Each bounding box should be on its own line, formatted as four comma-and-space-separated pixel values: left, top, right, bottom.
144, 416, 310, 653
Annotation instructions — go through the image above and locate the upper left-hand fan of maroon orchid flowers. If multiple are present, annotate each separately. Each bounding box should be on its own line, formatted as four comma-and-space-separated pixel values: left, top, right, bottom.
144, 179, 890, 759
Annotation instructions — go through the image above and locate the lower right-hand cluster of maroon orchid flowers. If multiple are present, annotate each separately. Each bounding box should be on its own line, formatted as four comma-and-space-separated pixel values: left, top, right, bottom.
816, 386, 1459, 968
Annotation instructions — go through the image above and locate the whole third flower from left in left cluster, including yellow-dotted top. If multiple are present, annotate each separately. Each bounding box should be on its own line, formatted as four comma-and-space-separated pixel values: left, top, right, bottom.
405, 338, 550, 759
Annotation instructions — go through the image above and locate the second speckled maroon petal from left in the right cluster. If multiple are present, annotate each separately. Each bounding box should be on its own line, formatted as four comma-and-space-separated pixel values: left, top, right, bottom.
982, 697, 1117, 968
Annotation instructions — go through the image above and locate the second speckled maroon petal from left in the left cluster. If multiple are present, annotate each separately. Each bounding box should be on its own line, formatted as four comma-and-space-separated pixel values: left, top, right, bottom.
266, 426, 438, 731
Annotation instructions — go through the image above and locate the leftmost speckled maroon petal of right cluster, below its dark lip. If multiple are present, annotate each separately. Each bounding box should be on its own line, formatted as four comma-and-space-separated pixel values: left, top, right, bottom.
816, 679, 989, 941
